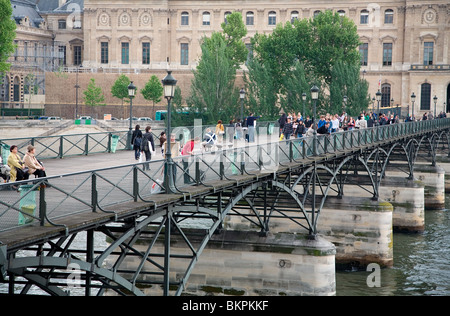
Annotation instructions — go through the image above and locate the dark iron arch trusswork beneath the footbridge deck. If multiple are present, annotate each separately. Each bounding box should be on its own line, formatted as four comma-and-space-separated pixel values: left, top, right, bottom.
0, 119, 450, 295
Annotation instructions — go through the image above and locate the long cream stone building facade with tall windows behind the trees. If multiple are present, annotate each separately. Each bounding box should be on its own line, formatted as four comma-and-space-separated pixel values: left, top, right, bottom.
3, 0, 450, 116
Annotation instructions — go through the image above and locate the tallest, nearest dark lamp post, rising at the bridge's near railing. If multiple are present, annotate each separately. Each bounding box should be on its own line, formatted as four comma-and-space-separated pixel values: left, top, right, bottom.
161, 70, 177, 193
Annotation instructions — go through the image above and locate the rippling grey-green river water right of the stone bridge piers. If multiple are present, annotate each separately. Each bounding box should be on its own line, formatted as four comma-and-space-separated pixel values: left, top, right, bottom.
336, 201, 450, 296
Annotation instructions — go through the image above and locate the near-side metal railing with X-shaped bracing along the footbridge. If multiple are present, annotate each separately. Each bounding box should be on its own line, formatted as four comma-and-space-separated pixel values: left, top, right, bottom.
0, 119, 450, 231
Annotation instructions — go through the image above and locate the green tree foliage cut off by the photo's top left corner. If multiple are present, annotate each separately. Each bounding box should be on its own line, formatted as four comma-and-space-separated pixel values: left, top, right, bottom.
0, 0, 16, 73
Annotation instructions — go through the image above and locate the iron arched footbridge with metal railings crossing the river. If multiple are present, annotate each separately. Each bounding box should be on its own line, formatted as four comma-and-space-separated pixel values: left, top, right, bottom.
0, 119, 450, 295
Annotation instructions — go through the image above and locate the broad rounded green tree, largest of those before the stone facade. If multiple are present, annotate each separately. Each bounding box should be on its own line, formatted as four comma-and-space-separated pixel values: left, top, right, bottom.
249, 10, 360, 114
